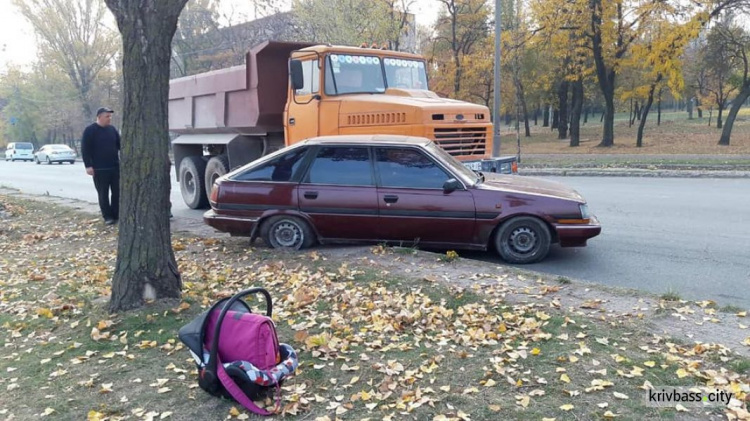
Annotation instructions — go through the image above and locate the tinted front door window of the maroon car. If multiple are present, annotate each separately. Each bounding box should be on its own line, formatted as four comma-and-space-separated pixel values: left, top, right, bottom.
375, 148, 451, 189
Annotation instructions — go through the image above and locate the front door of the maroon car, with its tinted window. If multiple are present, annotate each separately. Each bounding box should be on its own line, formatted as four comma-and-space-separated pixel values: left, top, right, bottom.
375, 146, 476, 245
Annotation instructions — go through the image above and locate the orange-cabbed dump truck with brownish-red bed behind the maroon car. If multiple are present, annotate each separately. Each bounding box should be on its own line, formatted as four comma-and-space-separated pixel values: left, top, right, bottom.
169, 41, 515, 209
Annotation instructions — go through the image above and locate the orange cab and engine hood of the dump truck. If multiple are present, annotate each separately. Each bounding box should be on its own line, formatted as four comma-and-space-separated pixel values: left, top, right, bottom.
284, 45, 492, 161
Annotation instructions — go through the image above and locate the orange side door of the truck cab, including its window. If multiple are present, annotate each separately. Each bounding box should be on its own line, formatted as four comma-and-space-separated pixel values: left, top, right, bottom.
284, 56, 320, 145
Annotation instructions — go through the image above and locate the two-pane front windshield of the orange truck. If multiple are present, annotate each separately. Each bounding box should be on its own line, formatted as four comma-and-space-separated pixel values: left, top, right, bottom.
325, 54, 427, 95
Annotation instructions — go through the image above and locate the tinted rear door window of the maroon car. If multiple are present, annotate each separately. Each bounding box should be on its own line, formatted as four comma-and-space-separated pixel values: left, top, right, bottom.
304, 146, 375, 186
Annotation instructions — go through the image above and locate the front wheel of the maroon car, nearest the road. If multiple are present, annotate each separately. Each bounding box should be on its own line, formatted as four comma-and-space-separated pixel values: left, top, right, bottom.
495, 216, 552, 264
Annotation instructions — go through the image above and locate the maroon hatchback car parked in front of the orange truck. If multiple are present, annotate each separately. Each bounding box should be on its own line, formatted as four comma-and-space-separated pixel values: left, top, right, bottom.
203, 135, 601, 263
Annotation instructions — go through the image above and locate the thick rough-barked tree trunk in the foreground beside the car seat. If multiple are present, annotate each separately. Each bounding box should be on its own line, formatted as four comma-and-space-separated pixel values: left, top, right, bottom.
105, 0, 187, 312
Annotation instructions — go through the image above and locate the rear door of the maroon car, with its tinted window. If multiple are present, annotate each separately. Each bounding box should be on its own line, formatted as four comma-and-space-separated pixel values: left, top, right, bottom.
298, 145, 379, 240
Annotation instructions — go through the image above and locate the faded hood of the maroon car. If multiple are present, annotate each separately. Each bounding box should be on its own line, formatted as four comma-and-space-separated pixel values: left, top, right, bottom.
477, 173, 586, 203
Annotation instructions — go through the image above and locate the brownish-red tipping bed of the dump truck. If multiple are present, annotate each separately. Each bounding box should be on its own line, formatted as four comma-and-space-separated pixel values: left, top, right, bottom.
169, 41, 314, 134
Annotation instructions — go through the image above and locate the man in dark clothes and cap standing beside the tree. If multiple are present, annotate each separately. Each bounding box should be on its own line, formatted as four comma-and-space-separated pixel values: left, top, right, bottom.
81, 107, 120, 225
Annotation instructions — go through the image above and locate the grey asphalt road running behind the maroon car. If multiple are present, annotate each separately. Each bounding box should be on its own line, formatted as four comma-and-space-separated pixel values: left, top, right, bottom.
0, 161, 750, 308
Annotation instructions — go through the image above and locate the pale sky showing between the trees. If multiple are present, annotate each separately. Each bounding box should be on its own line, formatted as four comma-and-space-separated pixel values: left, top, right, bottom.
0, 0, 439, 69
